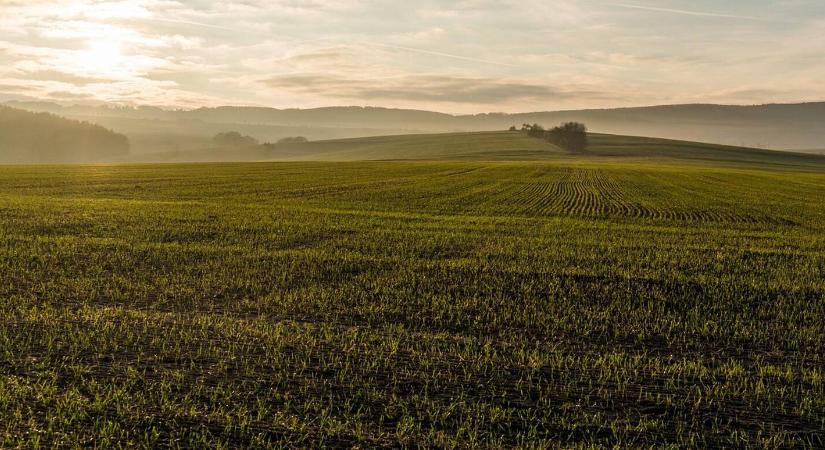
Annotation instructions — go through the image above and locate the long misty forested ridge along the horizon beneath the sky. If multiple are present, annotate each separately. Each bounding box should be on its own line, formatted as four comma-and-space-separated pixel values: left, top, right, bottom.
6, 102, 825, 152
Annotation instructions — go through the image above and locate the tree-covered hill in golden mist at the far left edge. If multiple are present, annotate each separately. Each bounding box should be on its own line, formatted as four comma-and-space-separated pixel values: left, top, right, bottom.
0, 106, 129, 163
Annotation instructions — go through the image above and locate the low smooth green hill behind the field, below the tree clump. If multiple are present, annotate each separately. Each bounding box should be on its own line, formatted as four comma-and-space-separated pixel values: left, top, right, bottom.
134, 131, 825, 167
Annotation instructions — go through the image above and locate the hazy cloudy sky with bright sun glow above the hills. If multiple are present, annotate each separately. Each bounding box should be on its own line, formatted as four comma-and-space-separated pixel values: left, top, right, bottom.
0, 0, 825, 112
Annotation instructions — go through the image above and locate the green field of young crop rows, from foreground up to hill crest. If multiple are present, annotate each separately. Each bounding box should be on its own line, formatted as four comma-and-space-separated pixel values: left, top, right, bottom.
0, 133, 825, 448
